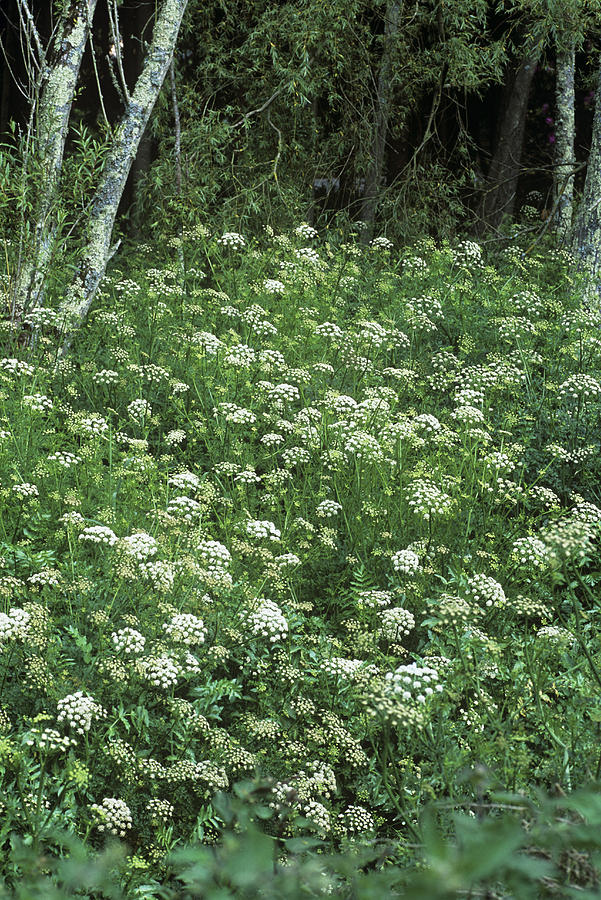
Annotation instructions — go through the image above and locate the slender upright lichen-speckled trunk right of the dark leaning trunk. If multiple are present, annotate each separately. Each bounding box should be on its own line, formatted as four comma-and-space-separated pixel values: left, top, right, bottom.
553, 37, 576, 244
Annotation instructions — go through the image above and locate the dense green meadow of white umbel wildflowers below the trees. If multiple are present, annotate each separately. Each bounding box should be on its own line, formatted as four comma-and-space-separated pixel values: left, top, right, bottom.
0, 224, 601, 900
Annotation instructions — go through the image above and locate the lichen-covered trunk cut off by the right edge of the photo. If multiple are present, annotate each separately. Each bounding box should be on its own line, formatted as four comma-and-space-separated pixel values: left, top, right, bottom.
572, 56, 601, 303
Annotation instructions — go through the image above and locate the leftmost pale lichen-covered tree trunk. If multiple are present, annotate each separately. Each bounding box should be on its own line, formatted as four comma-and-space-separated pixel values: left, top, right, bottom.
13, 0, 97, 313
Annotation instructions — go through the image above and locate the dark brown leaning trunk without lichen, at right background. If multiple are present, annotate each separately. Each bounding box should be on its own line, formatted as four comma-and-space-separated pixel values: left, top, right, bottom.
479, 46, 541, 232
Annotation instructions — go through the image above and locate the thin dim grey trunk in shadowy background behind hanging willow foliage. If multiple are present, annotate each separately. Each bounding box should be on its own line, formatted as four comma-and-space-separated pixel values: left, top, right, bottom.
359, 0, 401, 233
